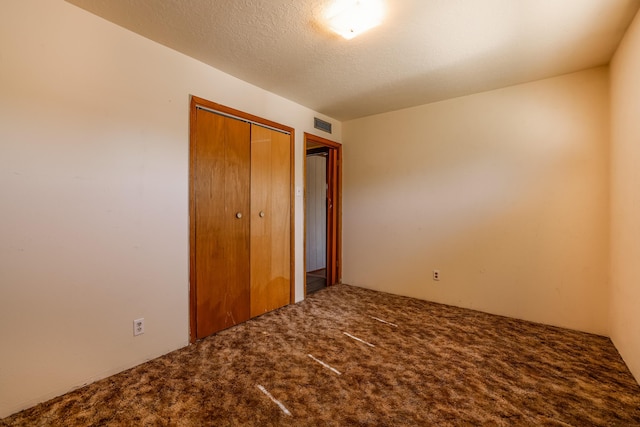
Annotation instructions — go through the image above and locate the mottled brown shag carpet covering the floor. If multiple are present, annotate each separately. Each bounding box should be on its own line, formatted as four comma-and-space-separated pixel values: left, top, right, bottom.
0, 285, 640, 426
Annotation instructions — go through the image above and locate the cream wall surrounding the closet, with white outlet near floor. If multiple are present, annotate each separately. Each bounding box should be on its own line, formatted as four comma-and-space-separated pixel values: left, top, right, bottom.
0, 0, 341, 417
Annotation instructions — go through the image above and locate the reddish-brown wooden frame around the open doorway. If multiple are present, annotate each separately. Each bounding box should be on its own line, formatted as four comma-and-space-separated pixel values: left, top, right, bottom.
303, 132, 342, 297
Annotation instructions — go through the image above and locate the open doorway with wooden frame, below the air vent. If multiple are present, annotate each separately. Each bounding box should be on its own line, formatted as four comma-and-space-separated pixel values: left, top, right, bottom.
304, 133, 342, 294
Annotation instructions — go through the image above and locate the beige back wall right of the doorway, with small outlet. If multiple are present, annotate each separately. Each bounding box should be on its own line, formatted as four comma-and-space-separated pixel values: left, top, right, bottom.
343, 68, 612, 334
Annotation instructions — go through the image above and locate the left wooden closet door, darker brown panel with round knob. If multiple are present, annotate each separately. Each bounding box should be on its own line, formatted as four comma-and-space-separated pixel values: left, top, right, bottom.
193, 109, 251, 338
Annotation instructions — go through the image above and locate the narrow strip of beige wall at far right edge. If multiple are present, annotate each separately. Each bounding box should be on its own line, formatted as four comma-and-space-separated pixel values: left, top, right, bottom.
611, 10, 640, 379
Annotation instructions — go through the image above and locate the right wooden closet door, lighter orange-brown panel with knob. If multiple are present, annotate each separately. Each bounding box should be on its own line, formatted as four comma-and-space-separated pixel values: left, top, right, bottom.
251, 125, 291, 317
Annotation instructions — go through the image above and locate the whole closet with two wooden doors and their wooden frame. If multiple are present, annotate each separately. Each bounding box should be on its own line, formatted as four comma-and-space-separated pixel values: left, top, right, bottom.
190, 97, 293, 341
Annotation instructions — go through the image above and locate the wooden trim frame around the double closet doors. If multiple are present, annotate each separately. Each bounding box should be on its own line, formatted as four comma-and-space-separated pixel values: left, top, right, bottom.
189, 95, 296, 343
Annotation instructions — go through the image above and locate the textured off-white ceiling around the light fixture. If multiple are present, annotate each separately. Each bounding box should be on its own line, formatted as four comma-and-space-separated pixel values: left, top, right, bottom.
67, 0, 640, 120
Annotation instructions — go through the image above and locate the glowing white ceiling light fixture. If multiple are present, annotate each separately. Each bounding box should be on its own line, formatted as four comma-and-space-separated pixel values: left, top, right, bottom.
327, 0, 384, 40
